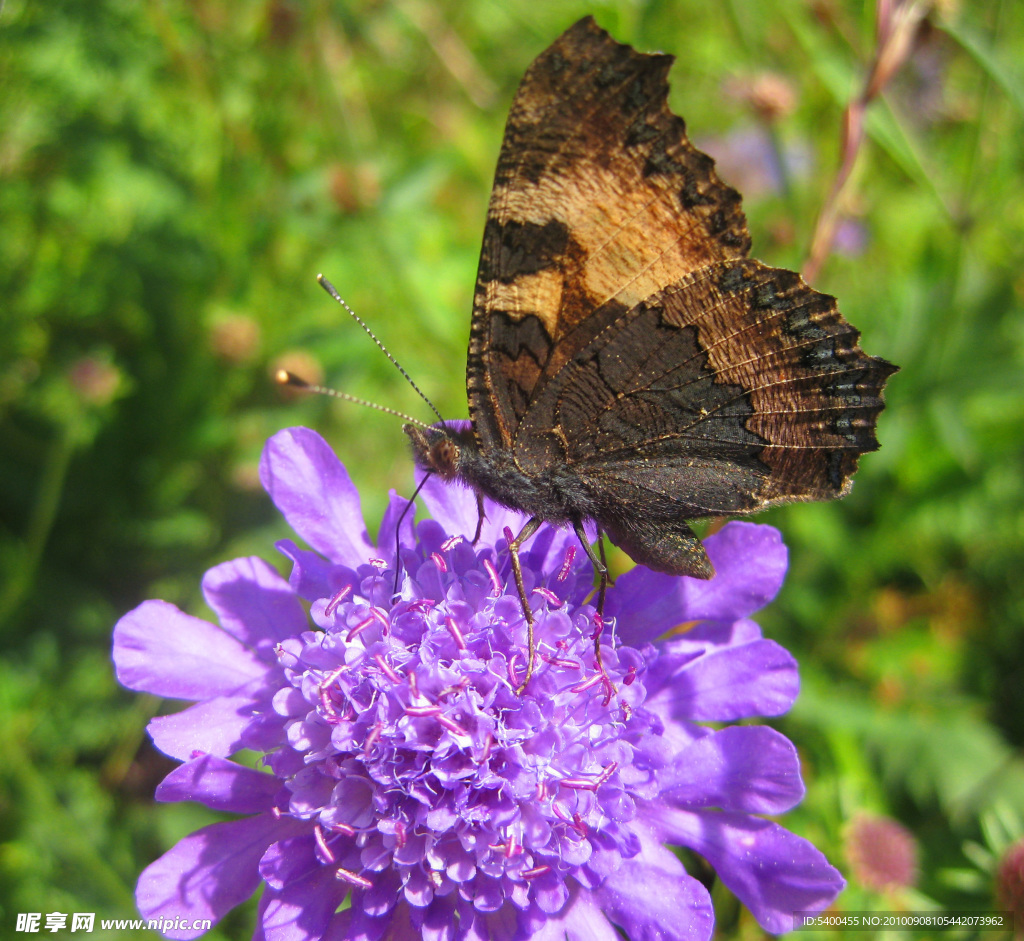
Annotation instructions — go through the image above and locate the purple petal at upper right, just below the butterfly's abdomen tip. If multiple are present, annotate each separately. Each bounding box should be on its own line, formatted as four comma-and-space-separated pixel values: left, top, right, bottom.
679, 520, 788, 621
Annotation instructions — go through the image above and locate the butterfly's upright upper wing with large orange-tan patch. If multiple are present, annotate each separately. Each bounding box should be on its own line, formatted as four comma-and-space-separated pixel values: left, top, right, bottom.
466, 17, 750, 448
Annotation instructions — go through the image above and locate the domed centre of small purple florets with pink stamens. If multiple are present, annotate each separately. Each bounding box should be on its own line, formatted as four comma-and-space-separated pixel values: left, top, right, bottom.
275, 546, 650, 910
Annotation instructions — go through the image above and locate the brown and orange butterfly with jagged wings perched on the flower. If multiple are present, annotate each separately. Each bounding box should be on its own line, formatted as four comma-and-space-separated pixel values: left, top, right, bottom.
404, 16, 897, 684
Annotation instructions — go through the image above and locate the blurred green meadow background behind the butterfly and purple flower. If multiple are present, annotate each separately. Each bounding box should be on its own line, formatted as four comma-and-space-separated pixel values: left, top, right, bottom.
0, 0, 1024, 939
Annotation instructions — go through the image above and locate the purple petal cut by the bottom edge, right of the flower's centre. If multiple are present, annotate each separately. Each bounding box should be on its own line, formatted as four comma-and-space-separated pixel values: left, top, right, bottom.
594, 835, 715, 941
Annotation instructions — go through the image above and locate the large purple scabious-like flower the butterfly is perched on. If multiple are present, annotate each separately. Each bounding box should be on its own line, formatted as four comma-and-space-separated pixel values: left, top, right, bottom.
114, 428, 843, 941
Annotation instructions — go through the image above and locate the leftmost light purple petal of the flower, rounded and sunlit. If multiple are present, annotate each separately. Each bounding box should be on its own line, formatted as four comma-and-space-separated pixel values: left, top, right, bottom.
114, 601, 266, 699
